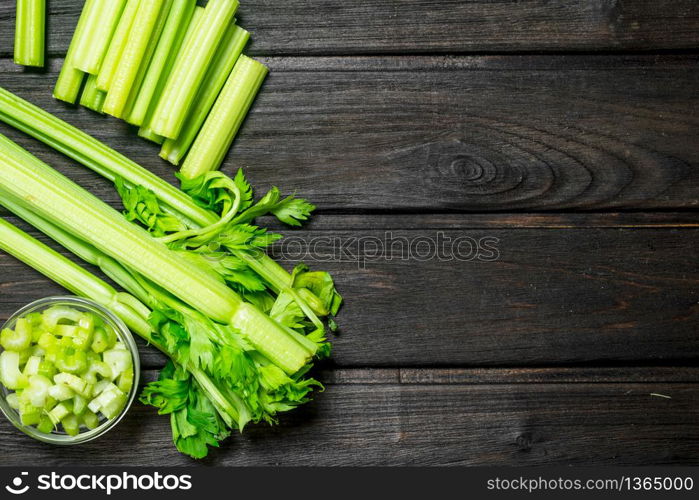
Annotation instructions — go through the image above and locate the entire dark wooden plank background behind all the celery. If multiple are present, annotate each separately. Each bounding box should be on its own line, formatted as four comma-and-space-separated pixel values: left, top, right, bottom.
0, 0, 699, 465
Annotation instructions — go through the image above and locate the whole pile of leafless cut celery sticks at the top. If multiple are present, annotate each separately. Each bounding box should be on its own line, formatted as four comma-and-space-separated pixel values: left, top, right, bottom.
54, 0, 267, 178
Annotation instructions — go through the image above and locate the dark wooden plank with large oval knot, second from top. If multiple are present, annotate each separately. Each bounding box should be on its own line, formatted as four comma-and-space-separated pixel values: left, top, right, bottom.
0, 56, 699, 213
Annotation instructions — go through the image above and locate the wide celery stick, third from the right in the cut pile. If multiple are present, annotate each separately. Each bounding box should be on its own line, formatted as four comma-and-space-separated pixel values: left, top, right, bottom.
152, 0, 238, 139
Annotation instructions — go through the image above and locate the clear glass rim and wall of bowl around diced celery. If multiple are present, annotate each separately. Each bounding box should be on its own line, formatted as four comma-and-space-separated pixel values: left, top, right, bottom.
0, 296, 141, 445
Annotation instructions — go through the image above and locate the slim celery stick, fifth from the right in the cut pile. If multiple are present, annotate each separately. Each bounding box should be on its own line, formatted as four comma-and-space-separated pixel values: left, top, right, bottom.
127, 0, 197, 127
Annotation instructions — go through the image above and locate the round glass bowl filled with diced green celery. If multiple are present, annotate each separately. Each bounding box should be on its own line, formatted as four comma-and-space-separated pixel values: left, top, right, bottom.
0, 297, 140, 444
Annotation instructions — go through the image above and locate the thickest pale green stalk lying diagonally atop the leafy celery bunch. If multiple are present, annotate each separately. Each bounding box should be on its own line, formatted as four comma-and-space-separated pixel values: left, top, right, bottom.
0, 136, 314, 374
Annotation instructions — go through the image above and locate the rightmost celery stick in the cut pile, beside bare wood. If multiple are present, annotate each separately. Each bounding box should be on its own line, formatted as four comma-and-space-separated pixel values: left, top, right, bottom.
180, 56, 268, 179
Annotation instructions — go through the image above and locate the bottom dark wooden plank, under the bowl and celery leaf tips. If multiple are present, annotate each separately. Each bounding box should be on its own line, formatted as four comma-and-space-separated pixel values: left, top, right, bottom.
0, 369, 699, 466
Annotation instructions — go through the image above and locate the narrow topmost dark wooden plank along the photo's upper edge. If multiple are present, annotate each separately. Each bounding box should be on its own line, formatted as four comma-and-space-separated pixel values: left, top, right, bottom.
0, 0, 699, 55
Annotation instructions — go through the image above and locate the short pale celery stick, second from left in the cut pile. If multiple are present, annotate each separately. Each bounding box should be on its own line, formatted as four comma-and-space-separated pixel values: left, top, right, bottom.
73, 0, 126, 75
